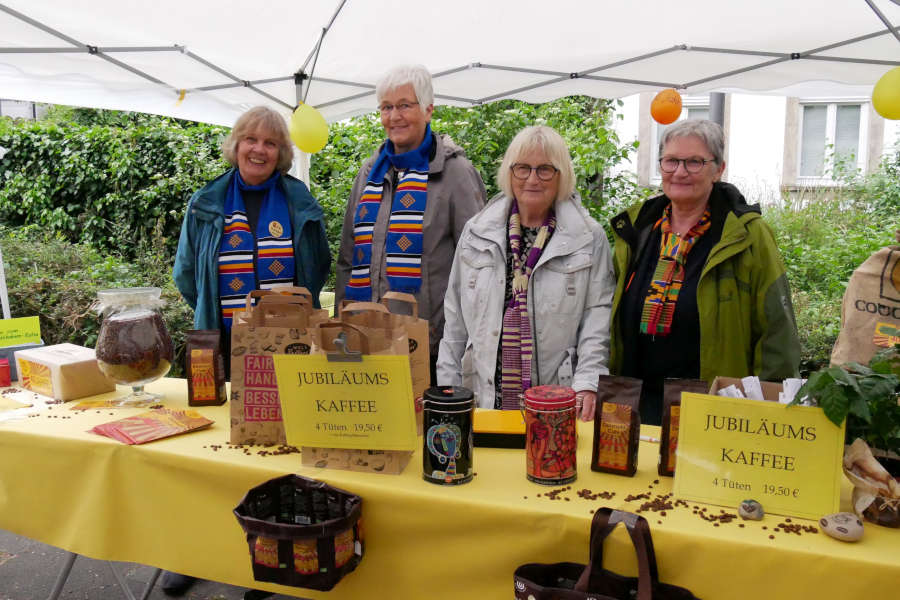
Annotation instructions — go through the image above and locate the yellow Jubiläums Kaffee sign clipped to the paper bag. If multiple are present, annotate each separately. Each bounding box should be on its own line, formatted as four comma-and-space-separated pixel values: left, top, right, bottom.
274, 354, 417, 450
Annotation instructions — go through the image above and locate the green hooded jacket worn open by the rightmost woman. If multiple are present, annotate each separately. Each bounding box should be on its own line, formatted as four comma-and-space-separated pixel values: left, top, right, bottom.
610, 182, 800, 382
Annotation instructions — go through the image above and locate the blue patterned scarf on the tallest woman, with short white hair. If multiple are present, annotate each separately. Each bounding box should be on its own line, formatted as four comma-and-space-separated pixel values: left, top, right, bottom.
345, 124, 434, 302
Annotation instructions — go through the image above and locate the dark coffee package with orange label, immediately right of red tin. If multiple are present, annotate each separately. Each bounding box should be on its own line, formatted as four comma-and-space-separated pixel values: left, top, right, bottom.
591, 375, 642, 477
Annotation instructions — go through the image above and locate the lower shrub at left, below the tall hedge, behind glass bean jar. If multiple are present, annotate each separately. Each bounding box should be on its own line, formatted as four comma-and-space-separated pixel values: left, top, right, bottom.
0, 226, 194, 377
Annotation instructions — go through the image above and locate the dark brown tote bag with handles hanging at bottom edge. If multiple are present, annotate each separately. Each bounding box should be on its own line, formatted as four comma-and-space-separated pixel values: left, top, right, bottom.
514, 508, 696, 600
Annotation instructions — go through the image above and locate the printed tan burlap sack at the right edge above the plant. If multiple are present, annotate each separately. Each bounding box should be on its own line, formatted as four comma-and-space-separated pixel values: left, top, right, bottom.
831, 246, 900, 365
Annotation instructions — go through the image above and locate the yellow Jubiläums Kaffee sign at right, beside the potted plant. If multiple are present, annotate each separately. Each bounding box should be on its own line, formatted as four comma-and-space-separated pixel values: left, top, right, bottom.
673, 393, 844, 519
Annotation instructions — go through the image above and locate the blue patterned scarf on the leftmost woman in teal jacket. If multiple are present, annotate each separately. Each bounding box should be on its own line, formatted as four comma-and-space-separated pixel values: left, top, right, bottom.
219, 170, 294, 330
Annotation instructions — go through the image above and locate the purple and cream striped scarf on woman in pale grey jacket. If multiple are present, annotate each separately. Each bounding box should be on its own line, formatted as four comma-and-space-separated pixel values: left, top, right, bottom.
500, 199, 556, 410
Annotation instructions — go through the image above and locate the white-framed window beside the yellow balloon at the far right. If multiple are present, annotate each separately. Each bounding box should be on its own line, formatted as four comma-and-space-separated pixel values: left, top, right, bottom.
797, 100, 868, 184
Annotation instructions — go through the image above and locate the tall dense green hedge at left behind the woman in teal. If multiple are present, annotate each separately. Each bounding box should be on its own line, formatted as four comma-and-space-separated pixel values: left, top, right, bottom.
0, 116, 227, 258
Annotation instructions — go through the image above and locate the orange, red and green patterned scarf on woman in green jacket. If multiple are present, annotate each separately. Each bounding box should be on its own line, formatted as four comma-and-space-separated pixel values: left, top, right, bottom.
641, 204, 710, 335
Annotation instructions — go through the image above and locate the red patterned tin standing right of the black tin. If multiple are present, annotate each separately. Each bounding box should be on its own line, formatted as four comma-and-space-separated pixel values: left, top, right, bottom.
525, 385, 578, 485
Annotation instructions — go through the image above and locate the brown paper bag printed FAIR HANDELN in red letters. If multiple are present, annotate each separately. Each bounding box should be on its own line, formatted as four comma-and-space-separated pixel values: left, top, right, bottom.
231, 295, 310, 444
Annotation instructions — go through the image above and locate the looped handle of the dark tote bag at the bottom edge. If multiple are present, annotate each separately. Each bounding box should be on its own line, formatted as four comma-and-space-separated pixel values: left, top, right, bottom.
573, 508, 659, 600
